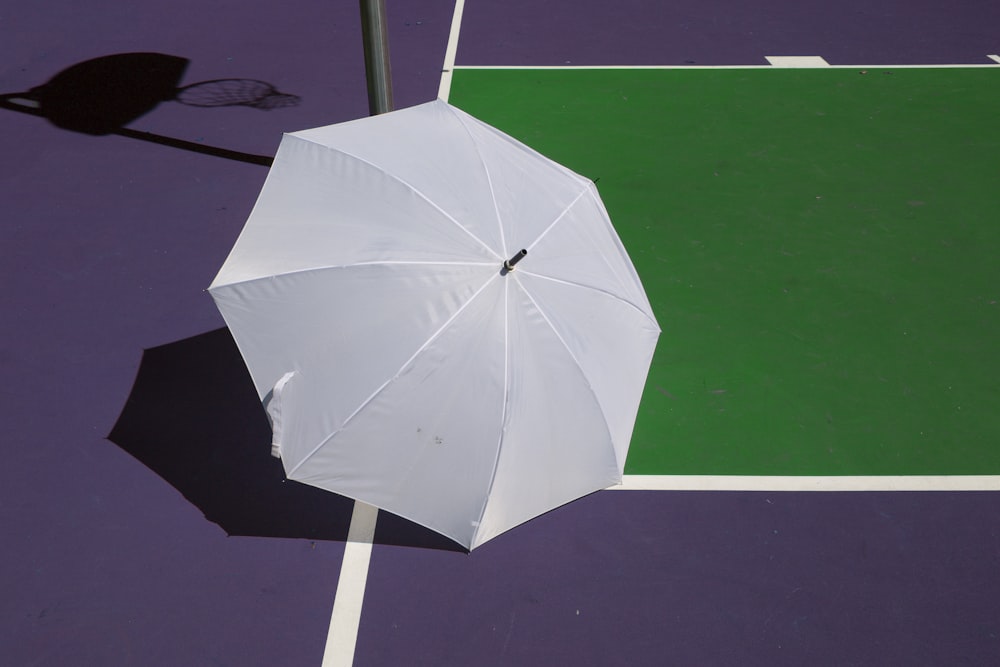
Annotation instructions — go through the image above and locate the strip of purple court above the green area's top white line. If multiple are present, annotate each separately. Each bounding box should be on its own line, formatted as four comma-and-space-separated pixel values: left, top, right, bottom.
458, 0, 1000, 65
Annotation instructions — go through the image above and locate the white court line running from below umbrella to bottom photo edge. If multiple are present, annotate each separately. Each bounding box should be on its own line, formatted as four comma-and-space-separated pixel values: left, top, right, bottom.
323, 500, 378, 667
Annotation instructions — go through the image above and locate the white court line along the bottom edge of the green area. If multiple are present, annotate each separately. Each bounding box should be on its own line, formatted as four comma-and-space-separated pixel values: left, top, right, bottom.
608, 475, 1000, 491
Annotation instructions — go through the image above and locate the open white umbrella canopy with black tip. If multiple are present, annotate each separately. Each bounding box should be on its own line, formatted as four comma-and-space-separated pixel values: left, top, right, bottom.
209, 100, 659, 549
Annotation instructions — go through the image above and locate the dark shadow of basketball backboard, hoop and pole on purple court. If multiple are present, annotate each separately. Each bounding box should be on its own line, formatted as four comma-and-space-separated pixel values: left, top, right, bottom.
0, 53, 299, 166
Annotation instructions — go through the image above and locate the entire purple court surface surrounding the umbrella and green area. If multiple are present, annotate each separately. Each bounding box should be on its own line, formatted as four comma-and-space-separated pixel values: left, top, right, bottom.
0, 0, 1000, 667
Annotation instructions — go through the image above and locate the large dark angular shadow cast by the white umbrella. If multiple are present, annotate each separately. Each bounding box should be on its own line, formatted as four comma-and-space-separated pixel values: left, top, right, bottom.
108, 328, 465, 552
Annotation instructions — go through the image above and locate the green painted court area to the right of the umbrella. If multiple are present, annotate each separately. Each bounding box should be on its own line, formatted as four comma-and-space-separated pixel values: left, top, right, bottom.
451, 68, 1000, 475
